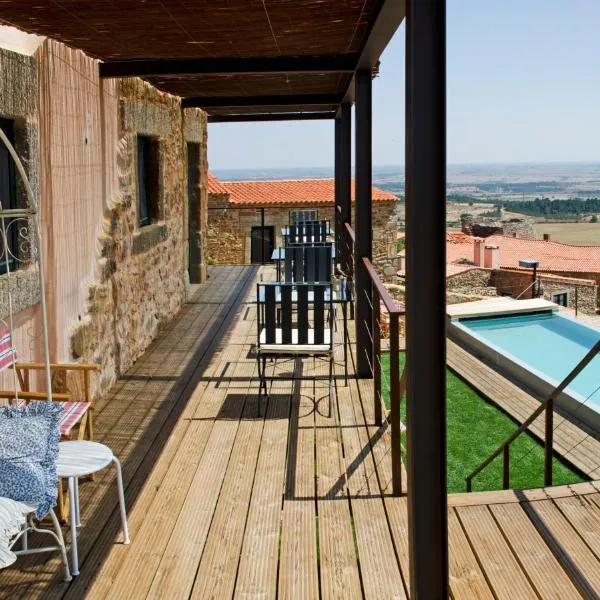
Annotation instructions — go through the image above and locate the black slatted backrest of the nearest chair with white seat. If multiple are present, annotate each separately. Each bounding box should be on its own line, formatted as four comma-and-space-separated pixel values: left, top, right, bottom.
257, 283, 333, 349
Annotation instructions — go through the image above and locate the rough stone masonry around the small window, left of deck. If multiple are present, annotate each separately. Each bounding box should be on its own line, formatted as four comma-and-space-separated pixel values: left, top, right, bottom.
71, 79, 206, 392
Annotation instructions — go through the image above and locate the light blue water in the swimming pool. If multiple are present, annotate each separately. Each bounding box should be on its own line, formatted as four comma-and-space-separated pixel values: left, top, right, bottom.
460, 312, 600, 412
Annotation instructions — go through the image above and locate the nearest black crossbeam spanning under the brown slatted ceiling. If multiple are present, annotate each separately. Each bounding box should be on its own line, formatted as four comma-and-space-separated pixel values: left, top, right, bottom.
99, 54, 359, 78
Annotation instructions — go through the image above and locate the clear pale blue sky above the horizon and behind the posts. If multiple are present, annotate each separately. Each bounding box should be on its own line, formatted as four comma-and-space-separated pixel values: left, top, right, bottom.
209, 0, 600, 169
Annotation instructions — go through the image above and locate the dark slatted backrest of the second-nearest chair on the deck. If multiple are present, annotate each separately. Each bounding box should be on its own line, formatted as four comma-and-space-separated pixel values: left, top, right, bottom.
283, 243, 333, 283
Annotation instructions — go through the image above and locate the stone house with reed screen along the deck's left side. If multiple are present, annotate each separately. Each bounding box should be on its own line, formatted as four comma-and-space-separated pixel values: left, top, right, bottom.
0, 27, 207, 394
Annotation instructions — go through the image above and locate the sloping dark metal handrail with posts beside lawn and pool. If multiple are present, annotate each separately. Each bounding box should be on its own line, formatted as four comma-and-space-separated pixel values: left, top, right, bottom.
465, 341, 600, 492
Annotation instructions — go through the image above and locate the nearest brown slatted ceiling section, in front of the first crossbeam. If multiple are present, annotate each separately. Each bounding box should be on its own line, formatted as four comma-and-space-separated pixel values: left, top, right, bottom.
0, 0, 376, 60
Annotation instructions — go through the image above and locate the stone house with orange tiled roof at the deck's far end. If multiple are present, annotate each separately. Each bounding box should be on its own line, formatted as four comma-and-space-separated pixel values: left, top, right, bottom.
206, 174, 397, 279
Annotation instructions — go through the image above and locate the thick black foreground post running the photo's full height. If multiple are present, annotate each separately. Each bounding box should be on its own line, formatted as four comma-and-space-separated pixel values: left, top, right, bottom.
406, 0, 448, 600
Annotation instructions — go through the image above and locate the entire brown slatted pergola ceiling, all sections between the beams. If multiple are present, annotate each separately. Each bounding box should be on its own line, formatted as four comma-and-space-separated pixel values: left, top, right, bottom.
0, 0, 401, 114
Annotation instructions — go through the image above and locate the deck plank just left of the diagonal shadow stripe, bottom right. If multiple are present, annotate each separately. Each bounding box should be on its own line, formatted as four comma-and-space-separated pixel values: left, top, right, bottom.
490, 504, 581, 600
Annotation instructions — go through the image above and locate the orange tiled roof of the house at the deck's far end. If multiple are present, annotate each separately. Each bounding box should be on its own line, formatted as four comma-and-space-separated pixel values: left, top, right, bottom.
222, 179, 397, 206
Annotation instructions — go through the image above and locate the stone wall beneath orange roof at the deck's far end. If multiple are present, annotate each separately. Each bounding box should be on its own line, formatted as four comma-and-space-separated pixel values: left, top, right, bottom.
207, 200, 398, 282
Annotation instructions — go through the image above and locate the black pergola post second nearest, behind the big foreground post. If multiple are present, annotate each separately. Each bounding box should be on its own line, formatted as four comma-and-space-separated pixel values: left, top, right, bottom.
354, 71, 373, 377
